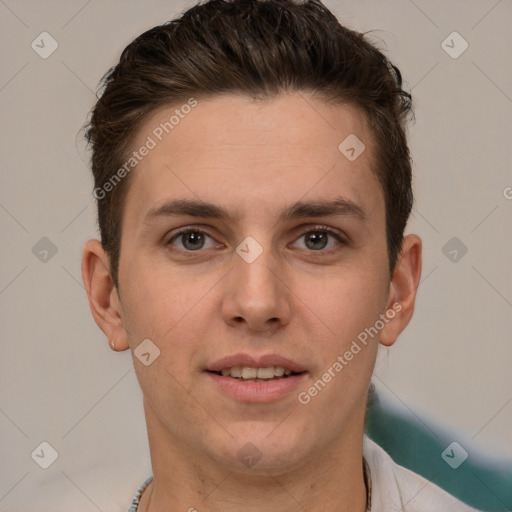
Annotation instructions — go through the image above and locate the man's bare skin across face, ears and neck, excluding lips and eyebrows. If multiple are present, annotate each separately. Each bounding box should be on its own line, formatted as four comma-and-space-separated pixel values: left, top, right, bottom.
82, 93, 421, 512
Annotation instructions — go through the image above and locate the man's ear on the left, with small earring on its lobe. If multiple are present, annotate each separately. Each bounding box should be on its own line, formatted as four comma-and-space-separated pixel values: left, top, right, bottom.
82, 240, 129, 351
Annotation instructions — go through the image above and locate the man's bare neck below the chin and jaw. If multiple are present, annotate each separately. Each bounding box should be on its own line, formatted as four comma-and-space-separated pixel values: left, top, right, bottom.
138, 405, 366, 512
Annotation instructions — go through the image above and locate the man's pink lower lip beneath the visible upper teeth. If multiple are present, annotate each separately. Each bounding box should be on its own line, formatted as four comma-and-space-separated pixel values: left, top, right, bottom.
206, 372, 307, 402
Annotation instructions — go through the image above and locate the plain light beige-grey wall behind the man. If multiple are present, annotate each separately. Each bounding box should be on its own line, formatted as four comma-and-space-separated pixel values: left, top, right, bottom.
0, 0, 512, 512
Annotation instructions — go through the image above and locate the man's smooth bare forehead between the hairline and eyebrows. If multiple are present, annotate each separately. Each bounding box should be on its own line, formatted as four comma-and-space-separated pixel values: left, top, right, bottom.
125, 93, 382, 228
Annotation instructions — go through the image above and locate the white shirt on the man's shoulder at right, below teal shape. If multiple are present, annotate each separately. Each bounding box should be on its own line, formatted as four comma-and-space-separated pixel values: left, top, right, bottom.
363, 435, 478, 512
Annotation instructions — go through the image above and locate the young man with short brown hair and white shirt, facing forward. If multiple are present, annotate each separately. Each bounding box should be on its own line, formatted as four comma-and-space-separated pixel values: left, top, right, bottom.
82, 0, 482, 512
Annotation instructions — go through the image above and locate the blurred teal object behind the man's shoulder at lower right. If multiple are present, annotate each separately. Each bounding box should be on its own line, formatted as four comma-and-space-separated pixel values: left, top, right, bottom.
366, 390, 512, 512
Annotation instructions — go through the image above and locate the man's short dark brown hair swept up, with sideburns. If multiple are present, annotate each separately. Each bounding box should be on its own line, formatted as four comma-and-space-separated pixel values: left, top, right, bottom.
86, 0, 413, 287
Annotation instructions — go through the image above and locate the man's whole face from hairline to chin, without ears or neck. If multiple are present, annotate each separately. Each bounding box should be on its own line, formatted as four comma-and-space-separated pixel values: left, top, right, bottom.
94, 94, 404, 470
